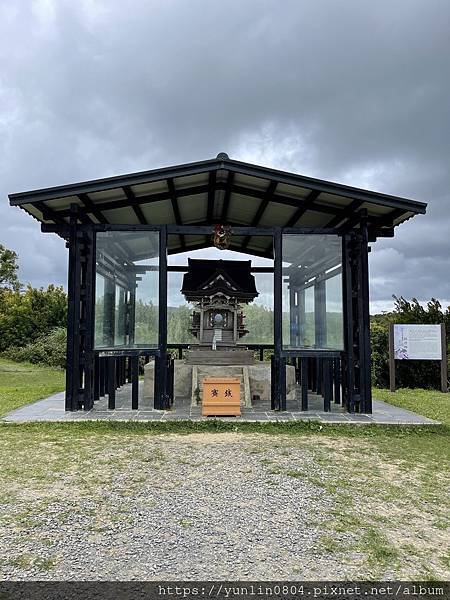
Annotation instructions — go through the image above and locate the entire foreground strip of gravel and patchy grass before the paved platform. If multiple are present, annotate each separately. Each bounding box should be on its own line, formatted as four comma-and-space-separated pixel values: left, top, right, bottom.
0, 429, 450, 581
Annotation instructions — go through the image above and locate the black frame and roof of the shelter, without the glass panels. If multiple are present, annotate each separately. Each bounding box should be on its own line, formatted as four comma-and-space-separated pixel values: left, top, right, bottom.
9, 153, 426, 413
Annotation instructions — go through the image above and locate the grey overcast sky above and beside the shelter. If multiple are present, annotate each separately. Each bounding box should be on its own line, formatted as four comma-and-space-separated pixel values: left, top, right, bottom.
0, 0, 450, 312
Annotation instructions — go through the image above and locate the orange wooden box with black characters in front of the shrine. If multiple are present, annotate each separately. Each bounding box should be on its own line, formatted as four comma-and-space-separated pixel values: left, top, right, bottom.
202, 377, 241, 417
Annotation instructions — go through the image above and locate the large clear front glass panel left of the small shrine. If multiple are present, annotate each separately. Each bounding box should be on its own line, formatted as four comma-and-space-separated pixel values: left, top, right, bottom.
95, 231, 159, 349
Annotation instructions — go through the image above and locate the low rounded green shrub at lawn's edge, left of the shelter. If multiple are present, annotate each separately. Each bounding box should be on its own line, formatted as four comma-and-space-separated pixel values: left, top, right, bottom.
3, 327, 67, 368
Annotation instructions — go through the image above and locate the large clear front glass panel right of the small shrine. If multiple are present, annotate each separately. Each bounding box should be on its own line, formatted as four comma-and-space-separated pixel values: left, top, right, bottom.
283, 234, 344, 350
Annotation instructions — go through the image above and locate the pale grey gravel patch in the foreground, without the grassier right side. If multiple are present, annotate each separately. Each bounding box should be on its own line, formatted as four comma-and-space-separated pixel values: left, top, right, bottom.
0, 434, 350, 580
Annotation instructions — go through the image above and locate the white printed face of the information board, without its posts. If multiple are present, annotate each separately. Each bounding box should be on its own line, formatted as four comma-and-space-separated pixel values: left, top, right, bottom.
394, 325, 442, 360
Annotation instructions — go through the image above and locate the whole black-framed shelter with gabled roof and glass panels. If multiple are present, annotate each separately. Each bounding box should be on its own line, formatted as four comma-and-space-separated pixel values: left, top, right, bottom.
9, 153, 426, 413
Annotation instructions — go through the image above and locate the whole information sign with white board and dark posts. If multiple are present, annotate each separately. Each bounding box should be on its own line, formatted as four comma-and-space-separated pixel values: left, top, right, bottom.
389, 323, 448, 393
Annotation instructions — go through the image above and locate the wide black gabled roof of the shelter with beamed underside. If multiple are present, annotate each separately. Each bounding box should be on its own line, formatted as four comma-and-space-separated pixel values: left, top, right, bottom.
9, 153, 427, 254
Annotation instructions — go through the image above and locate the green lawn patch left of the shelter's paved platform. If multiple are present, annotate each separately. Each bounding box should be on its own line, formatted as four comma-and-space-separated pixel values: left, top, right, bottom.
0, 358, 65, 416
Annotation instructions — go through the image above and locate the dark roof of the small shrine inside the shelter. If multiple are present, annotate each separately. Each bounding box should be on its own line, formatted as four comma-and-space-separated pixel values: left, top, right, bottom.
181, 258, 258, 300
